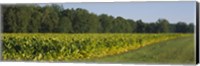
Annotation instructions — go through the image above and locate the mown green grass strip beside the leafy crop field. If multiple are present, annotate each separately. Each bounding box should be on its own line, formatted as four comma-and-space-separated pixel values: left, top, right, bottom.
80, 36, 195, 64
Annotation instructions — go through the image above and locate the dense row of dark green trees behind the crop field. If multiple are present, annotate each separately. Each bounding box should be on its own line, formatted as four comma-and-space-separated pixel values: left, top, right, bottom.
2, 4, 194, 33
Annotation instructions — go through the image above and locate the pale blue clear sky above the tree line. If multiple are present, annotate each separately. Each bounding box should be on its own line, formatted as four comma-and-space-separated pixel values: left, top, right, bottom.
39, 1, 196, 24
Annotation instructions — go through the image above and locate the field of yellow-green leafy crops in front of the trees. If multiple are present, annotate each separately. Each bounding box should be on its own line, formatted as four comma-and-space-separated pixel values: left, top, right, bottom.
2, 33, 192, 61
